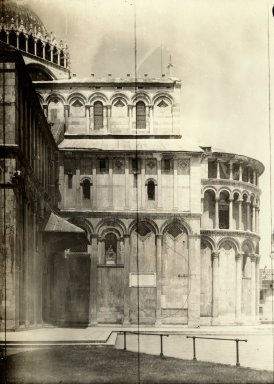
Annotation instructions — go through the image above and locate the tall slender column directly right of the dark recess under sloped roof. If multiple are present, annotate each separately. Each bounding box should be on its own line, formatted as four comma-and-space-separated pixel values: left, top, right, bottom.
88, 237, 98, 326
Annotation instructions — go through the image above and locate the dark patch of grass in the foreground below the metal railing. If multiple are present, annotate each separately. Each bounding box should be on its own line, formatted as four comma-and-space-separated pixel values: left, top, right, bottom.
3, 346, 273, 384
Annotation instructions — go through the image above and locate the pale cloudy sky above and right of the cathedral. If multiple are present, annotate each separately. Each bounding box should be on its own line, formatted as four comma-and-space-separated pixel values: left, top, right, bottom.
25, 0, 274, 267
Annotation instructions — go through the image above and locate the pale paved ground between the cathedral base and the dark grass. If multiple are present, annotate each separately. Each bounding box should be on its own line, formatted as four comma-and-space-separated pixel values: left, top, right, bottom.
0, 325, 274, 370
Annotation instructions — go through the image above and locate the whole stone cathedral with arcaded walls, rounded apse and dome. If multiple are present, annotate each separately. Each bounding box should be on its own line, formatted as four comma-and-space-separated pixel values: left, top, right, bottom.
0, 0, 264, 330
